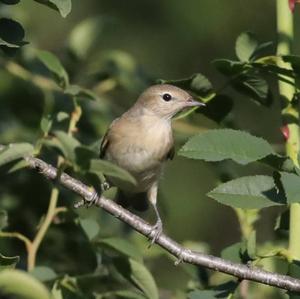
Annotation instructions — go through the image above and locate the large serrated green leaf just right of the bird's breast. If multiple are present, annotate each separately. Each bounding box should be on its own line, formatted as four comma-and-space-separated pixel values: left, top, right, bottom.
179, 129, 274, 165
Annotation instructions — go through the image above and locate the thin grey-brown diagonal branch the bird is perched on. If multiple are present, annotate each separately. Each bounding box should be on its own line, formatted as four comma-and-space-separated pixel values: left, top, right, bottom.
26, 157, 300, 293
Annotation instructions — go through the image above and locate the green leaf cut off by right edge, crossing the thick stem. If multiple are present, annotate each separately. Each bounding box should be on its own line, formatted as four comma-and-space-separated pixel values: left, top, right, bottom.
280, 172, 300, 204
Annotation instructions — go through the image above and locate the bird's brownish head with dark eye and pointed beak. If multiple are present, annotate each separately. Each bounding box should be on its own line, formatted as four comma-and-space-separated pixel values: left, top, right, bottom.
137, 84, 205, 119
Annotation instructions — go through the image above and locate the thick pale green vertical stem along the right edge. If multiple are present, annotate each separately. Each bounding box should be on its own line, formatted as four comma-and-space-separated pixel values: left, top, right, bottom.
277, 0, 300, 260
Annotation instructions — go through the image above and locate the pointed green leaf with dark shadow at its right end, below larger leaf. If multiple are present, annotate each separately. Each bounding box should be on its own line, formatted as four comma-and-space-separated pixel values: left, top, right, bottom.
207, 175, 285, 209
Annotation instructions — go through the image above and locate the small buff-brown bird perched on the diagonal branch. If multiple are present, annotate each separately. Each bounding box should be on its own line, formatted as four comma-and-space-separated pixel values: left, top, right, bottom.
100, 84, 205, 244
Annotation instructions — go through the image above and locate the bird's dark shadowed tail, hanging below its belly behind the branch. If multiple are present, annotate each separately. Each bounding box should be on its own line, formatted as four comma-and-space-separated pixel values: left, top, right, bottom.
116, 189, 149, 212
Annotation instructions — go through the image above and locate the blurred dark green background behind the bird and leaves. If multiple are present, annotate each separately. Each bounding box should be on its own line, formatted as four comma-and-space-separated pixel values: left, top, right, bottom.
0, 0, 300, 298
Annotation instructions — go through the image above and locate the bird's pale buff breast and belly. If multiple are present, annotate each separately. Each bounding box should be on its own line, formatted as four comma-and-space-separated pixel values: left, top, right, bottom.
107, 119, 173, 182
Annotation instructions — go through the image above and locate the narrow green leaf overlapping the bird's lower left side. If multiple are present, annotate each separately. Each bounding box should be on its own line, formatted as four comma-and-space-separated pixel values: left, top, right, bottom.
89, 159, 136, 185
